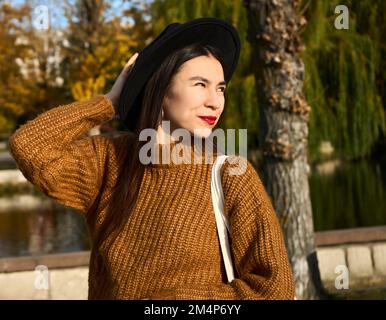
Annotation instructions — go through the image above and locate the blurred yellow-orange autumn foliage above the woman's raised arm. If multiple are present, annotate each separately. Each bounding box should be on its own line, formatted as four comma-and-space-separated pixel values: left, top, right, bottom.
0, 2, 145, 132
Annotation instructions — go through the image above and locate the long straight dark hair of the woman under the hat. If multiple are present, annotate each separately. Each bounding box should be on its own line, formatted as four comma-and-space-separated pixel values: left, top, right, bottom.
88, 43, 224, 284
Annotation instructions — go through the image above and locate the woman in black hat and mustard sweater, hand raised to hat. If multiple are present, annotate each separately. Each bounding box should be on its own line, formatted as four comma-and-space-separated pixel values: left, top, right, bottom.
10, 18, 294, 299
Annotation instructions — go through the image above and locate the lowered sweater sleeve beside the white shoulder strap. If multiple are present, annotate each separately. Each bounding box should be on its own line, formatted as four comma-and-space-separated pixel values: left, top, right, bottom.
153, 159, 295, 300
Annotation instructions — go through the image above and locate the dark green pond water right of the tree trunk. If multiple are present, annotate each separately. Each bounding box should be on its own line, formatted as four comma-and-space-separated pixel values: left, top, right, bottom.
309, 159, 386, 231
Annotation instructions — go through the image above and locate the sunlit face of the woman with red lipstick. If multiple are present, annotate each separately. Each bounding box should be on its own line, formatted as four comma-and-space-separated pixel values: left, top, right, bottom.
163, 56, 226, 138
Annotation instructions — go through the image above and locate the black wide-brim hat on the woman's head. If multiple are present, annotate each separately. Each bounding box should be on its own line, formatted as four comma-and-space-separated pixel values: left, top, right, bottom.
118, 17, 240, 131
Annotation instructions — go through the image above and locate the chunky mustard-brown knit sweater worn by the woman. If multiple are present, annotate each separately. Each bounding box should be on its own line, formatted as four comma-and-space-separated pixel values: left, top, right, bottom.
10, 95, 295, 300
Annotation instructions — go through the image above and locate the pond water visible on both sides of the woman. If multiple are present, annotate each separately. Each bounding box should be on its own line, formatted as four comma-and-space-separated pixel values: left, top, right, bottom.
0, 161, 386, 257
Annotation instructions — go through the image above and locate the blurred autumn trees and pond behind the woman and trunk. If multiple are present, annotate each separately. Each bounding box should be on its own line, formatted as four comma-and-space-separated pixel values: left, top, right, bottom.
0, 0, 386, 300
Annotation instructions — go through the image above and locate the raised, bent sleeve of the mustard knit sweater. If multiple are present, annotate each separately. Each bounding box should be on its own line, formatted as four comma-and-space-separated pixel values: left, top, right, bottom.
9, 95, 115, 214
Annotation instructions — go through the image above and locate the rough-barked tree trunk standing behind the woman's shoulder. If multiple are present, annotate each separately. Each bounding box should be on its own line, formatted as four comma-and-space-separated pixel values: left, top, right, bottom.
244, 0, 324, 299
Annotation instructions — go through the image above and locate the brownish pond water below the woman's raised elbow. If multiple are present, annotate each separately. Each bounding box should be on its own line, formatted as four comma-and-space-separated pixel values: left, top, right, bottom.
0, 206, 90, 257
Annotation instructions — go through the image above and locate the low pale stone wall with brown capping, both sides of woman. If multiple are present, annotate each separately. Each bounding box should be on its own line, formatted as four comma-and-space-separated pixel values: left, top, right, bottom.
0, 227, 386, 299
